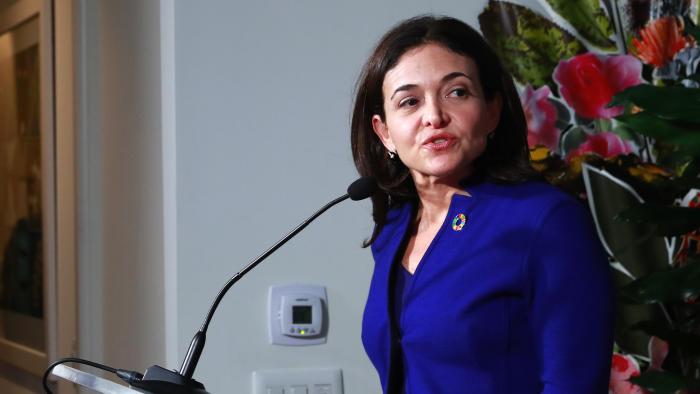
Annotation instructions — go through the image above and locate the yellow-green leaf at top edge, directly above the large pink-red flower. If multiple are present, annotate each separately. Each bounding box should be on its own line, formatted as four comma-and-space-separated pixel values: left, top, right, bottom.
547, 0, 615, 50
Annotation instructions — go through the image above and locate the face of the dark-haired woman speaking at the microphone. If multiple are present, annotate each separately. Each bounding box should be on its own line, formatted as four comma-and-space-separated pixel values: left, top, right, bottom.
372, 44, 501, 185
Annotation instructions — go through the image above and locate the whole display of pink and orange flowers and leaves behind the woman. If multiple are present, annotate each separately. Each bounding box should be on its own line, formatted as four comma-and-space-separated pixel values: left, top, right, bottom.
479, 0, 700, 393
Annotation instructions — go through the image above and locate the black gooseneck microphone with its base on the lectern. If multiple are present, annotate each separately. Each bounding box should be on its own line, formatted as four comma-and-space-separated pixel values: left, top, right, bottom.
129, 177, 377, 394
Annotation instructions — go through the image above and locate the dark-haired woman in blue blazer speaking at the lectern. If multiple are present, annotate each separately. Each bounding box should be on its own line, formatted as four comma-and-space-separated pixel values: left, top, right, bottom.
352, 16, 613, 394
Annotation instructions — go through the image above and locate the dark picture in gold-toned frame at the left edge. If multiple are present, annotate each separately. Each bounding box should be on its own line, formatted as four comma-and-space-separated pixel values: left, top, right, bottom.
0, 0, 56, 376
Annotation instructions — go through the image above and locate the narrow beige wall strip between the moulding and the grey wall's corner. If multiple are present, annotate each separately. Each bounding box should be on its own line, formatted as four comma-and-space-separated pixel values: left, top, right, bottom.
100, 0, 165, 369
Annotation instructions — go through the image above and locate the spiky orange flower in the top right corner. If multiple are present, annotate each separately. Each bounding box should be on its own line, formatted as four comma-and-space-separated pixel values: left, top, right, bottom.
632, 16, 690, 67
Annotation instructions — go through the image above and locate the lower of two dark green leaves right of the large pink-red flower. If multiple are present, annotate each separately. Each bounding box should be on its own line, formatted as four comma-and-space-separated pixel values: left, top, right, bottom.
616, 113, 700, 154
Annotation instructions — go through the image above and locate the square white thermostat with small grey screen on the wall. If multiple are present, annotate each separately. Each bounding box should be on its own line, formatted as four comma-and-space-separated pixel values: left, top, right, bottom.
268, 285, 327, 346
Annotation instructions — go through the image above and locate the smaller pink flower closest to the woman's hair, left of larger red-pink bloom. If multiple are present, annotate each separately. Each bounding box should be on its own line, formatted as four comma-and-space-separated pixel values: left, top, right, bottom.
520, 85, 559, 151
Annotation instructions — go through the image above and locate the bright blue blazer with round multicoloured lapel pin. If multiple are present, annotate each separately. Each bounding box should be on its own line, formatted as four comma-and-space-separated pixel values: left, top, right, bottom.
362, 182, 614, 394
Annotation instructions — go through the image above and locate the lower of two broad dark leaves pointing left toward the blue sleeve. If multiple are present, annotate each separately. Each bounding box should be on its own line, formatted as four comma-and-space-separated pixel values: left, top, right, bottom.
620, 260, 700, 304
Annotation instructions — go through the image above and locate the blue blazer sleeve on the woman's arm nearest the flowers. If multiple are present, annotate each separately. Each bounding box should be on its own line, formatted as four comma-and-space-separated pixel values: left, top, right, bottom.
526, 199, 614, 394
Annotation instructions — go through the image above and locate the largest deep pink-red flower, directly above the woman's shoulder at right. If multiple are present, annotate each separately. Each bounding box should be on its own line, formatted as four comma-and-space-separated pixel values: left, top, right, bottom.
553, 53, 642, 119
